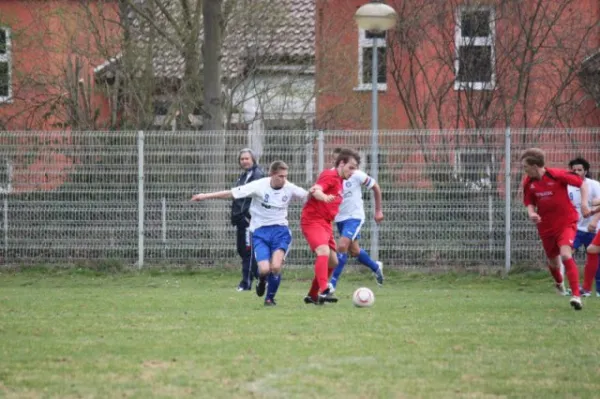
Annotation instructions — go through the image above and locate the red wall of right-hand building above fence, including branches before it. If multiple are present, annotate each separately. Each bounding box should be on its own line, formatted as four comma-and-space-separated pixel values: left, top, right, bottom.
316, 0, 600, 129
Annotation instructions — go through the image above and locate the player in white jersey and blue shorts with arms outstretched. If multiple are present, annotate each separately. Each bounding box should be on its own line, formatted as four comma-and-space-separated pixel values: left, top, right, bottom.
192, 161, 308, 306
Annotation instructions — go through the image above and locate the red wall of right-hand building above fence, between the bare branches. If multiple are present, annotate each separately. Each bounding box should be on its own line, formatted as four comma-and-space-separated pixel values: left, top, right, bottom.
316, 0, 600, 129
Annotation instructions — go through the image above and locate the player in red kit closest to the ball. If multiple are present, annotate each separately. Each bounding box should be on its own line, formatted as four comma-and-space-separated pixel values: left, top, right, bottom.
300, 149, 360, 304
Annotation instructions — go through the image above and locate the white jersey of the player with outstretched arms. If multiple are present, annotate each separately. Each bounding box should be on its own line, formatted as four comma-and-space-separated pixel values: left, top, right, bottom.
231, 177, 308, 231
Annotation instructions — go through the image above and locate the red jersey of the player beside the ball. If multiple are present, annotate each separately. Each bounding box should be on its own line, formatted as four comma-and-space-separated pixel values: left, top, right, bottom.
300, 169, 344, 223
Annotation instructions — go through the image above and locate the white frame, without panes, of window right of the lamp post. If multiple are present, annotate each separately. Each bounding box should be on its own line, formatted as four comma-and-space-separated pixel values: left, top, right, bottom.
454, 6, 496, 90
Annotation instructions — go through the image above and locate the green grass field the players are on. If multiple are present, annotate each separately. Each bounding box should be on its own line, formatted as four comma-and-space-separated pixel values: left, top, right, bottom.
0, 269, 600, 399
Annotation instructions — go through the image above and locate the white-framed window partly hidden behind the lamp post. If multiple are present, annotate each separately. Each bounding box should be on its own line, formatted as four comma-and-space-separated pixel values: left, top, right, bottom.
357, 29, 387, 90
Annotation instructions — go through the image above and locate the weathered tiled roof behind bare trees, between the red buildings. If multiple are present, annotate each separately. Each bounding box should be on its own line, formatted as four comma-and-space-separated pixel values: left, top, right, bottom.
95, 0, 315, 80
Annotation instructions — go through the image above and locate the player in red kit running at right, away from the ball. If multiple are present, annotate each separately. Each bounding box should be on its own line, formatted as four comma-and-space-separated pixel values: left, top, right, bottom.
521, 148, 590, 310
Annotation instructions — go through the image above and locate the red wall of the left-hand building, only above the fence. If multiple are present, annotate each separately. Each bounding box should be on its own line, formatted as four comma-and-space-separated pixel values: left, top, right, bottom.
0, 0, 120, 130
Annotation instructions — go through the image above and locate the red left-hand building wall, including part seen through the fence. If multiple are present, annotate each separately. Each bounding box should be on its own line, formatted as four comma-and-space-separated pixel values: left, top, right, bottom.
0, 0, 119, 192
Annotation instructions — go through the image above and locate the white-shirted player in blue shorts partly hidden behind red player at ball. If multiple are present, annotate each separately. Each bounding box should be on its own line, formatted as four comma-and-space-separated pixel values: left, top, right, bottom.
329, 149, 383, 293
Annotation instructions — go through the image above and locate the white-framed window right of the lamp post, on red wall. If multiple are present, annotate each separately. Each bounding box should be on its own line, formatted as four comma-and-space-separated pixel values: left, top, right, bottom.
454, 7, 496, 90
